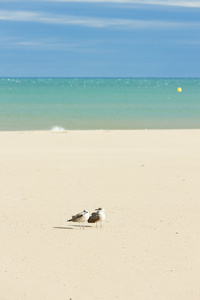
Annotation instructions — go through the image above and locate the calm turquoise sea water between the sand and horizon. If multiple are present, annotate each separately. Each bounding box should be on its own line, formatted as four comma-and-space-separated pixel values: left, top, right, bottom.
0, 78, 200, 131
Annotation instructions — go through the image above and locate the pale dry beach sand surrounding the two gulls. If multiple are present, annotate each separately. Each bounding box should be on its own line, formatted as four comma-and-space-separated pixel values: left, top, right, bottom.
0, 130, 200, 300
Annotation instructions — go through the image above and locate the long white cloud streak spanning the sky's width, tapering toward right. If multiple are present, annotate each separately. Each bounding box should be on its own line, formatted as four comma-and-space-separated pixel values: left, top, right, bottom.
0, 10, 200, 29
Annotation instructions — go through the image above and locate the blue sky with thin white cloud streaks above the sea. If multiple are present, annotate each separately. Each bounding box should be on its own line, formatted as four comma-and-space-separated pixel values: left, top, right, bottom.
0, 0, 200, 77
